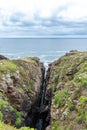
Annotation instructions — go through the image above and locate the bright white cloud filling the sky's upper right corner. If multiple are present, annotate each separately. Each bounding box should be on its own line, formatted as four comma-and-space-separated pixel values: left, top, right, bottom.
60, 0, 87, 21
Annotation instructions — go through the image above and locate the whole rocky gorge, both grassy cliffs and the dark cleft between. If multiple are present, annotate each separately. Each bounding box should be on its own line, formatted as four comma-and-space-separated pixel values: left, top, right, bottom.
0, 51, 87, 130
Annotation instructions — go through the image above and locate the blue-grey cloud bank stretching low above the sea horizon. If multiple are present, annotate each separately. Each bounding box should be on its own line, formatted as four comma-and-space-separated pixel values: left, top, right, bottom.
0, 12, 87, 36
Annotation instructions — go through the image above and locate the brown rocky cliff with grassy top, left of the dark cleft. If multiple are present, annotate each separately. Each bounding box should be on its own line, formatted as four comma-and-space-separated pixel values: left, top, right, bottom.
0, 56, 44, 127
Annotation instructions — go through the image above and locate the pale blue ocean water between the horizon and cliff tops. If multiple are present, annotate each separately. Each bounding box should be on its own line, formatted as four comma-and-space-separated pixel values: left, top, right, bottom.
0, 38, 87, 63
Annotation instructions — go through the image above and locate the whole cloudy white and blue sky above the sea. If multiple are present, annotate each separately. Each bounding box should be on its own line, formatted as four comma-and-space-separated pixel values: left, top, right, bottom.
0, 0, 87, 37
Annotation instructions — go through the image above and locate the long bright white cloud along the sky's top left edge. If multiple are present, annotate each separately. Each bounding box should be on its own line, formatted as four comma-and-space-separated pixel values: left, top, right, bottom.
0, 0, 69, 17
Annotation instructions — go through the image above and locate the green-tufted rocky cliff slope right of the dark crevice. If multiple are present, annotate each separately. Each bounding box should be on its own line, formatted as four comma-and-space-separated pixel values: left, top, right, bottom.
47, 51, 87, 130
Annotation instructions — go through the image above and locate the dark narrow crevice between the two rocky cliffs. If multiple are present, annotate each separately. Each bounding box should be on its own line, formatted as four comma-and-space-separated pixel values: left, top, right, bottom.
25, 62, 51, 130
